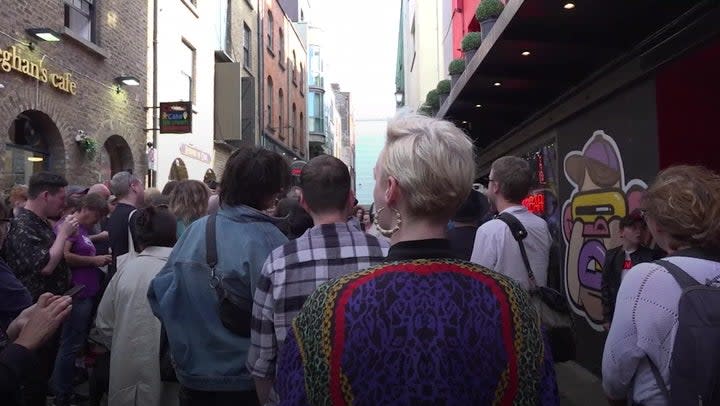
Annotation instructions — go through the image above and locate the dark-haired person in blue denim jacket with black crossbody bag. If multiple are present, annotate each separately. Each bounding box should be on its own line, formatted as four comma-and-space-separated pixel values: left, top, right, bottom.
148, 147, 290, 406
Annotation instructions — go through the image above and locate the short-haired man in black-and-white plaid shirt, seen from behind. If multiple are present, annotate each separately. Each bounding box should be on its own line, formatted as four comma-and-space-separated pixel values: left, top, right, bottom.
247, 155, 388, 404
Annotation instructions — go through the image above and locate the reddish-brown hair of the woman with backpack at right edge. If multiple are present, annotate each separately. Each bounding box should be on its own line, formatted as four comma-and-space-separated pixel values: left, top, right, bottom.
643, 165, 720, 249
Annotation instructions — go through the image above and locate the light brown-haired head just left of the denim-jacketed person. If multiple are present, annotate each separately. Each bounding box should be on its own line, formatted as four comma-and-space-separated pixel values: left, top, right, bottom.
170, 180, 210, 238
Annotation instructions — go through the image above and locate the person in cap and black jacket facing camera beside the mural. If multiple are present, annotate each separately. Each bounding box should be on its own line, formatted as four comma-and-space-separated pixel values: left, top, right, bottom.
602, 210, 655, 330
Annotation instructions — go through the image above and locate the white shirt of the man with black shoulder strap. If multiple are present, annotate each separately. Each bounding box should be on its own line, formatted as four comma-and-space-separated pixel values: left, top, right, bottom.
470, 206, 552, 289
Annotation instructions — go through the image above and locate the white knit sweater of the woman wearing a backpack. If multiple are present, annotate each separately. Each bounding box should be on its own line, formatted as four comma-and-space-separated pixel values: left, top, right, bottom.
602, 257, 720, 406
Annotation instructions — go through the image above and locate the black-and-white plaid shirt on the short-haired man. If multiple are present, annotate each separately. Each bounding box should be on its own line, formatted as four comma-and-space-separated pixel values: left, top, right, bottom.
247, 223, 388, 378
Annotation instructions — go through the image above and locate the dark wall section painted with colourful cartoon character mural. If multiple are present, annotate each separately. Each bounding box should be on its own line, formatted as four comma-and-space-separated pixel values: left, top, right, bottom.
555, 80, 658, 374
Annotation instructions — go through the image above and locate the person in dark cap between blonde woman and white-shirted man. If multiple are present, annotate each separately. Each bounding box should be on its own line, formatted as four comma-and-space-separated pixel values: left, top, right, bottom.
448, 190, 490, 261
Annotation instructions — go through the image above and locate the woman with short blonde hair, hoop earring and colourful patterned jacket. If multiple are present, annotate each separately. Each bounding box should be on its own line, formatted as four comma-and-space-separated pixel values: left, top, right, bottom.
276, 115, 558, 405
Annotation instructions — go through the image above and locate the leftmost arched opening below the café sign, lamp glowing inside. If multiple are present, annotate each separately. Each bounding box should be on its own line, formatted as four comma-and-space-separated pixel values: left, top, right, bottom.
3, 110, 65, 184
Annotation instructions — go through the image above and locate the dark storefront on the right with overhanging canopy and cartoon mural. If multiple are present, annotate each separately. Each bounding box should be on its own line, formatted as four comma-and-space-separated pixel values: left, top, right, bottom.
438, 1, 720, 374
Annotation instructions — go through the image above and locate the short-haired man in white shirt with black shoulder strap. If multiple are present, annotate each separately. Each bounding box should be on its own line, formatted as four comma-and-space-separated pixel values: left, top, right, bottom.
470, 156, 552, 289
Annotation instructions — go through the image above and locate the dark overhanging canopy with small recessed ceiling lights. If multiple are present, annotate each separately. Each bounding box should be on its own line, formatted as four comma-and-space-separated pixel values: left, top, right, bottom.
437, 0, 719, 150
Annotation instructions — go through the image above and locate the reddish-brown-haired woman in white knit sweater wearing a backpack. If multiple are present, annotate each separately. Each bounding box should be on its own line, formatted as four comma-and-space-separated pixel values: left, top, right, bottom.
602, 166, 720, 405
